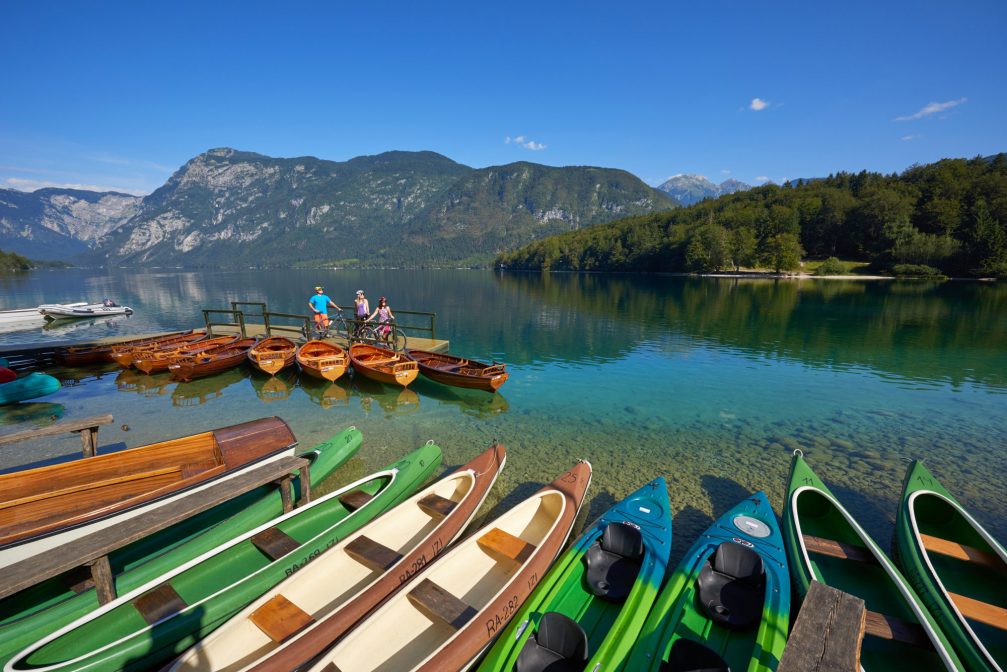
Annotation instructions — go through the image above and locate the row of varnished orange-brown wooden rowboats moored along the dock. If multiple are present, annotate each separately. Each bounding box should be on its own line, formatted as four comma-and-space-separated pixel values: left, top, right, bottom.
56, 331, 508, 392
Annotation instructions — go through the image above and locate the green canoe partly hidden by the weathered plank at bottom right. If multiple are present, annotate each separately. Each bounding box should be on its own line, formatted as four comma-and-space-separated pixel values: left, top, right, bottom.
783, 450, 965, 672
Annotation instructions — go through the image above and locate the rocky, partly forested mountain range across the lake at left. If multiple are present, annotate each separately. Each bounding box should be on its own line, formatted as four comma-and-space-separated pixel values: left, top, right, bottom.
0, 148, 678, 267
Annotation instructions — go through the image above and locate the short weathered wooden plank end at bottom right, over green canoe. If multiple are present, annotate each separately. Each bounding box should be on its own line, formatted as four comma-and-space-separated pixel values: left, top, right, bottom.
777, 581, 866, 672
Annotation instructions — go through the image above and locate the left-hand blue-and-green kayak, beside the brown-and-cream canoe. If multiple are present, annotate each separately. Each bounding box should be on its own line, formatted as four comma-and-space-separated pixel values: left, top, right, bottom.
479, 479, 672, 672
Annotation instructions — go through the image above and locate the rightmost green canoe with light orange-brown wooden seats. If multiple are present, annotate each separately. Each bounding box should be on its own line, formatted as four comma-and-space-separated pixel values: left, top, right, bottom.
895, 460, 1007, 672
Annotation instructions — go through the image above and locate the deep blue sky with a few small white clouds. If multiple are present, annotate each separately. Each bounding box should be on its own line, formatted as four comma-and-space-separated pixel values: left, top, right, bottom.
0, 0, 1007, 193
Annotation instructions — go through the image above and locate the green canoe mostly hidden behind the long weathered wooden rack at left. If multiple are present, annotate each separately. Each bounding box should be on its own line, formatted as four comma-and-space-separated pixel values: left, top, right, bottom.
0, 427, 362, 666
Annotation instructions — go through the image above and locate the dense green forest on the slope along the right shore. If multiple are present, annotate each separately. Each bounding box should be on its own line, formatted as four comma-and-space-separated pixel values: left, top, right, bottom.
495, 154, 1007, 278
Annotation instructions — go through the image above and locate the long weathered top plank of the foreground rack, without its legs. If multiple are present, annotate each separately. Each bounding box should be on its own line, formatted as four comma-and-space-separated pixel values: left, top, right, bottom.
0, 457, 307, 598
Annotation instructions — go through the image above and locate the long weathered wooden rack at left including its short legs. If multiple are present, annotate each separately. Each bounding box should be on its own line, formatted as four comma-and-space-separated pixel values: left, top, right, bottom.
0, 456, 311, 611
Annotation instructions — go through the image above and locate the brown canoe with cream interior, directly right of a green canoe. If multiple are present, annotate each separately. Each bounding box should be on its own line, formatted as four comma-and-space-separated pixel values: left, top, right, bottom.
168, 444, 507, 672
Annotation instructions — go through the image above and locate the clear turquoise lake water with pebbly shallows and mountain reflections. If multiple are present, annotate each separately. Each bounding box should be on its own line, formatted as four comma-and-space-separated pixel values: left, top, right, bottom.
0, 269, 1007, 562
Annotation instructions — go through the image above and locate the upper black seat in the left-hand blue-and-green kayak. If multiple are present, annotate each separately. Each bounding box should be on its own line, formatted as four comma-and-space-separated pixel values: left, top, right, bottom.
584, 523, 643, 602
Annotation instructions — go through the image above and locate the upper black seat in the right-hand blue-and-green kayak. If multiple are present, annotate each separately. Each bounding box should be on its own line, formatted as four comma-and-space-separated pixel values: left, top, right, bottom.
696, 541, 765, 630
